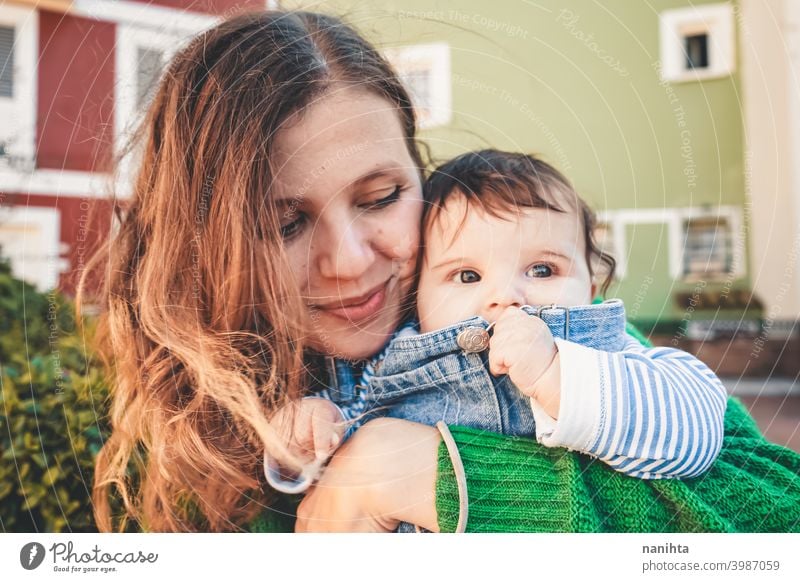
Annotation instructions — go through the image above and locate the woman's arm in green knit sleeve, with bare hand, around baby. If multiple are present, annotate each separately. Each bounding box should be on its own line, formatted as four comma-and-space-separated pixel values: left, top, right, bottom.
297, 399, 800, 532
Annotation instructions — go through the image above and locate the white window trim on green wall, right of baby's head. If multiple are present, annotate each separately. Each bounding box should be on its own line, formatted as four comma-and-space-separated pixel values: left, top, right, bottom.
598, 206, 745, 281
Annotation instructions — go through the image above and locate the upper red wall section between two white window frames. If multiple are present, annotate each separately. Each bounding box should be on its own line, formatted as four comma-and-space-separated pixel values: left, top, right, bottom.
36, 11, 116, 172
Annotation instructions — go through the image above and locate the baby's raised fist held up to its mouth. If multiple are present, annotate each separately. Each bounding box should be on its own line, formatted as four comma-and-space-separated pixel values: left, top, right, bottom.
489, 307, 560, 399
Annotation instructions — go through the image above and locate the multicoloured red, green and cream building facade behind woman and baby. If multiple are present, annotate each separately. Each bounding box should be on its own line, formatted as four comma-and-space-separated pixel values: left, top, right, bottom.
0, 0, 800, 374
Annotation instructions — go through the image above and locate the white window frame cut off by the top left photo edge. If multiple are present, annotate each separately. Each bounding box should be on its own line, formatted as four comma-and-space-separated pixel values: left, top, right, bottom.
0, 4, 39, 174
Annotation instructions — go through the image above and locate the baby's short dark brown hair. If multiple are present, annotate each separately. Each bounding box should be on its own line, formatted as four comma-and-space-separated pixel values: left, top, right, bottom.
422, 150, 616, 294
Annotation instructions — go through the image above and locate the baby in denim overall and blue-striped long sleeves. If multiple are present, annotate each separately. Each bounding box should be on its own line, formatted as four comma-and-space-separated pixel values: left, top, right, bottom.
267, 150, 727, 492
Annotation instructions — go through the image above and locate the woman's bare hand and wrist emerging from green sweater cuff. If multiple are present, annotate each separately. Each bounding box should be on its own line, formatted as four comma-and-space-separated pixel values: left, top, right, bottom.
295, 418, 441, 532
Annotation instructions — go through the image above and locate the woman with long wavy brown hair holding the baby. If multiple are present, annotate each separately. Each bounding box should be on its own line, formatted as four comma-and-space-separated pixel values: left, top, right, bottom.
83, 13, 800, 531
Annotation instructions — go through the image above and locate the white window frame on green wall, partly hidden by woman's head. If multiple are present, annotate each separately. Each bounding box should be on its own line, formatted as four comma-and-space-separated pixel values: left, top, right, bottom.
383, 42, 453, 129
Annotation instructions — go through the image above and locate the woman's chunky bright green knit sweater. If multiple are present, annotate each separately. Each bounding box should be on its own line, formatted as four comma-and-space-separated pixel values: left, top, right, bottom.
250, 398, 800, 532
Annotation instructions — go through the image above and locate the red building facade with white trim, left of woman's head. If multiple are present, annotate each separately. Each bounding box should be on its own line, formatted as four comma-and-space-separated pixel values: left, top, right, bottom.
0, 0, 265, 293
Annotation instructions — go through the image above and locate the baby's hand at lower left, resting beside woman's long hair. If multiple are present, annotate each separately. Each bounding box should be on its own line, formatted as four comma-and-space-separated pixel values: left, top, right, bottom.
270, 398, 345, 472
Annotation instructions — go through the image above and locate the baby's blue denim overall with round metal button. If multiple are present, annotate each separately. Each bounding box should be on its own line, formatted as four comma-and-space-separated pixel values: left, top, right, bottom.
366, 300, 627, 437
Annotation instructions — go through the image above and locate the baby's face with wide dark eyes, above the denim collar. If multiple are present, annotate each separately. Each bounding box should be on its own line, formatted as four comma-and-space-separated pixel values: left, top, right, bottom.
417, 196, 595, 332
